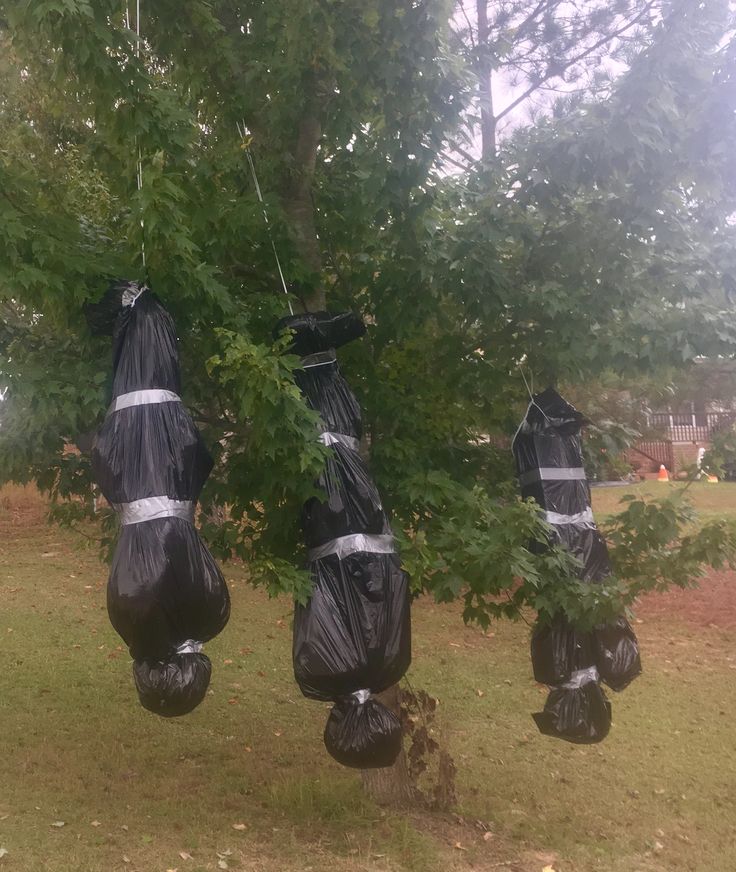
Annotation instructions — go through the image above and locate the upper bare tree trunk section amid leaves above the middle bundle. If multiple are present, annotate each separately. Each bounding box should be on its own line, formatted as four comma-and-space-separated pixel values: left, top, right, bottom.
283, 82, 325, 311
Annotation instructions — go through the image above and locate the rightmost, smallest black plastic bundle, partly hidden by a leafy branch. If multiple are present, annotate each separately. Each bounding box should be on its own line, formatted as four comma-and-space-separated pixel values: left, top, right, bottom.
512, 388, 641, 742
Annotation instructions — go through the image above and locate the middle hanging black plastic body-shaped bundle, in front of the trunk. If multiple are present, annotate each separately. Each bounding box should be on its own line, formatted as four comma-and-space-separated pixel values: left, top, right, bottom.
276, 312, 411, 769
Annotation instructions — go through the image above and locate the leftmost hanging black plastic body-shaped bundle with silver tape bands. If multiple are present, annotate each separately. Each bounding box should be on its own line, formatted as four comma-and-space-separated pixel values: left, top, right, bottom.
86, 282, 230, 717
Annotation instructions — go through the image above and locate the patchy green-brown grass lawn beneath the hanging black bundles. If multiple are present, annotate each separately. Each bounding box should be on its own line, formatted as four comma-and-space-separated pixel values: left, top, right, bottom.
0, 484, 736, 872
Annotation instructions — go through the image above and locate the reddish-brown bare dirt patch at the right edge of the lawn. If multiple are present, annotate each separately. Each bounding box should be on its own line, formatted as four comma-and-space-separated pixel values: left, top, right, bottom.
636, 570, 736, 630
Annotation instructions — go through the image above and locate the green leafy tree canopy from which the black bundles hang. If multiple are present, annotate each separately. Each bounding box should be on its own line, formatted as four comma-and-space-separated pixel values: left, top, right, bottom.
0, 0, 736, 621
